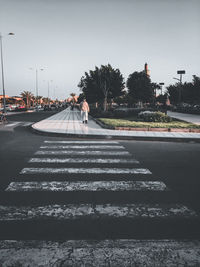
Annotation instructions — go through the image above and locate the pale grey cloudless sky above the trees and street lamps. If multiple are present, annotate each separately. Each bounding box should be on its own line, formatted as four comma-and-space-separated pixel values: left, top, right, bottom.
0, 0, 200, 99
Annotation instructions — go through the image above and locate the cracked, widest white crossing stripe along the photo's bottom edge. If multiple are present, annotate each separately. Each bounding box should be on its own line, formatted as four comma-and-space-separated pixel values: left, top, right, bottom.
0, 239, 200, 267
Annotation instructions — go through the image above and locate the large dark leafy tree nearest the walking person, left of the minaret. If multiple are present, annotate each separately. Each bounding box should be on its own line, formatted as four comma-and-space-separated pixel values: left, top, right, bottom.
78, 64, 125, 111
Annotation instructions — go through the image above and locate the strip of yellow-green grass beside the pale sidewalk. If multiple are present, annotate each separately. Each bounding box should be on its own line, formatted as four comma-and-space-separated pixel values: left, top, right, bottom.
99, 118, 200, 129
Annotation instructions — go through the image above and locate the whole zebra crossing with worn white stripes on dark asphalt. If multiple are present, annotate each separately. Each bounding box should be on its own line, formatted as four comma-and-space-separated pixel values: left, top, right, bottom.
0, 140, 200, 267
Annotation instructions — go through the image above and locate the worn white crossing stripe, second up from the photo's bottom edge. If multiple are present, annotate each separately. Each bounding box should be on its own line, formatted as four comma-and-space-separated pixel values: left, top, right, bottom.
0, 204, 197, 221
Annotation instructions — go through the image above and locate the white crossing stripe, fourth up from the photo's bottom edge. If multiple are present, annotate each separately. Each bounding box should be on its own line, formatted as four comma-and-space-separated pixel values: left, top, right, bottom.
20, 168, 151, 174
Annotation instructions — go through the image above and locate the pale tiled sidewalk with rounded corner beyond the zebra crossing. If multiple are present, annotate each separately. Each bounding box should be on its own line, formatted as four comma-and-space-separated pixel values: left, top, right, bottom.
32, 108, 200, 142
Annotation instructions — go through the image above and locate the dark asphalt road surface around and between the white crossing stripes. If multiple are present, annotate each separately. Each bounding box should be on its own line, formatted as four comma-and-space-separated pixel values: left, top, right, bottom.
0, 112, 200, 266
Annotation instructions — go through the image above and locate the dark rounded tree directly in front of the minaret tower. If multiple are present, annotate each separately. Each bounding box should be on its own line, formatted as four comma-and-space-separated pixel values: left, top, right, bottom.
127, 71, 159, 103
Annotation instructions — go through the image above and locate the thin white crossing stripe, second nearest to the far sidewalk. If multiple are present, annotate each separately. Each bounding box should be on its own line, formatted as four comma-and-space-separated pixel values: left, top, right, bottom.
40, 145, 125, 150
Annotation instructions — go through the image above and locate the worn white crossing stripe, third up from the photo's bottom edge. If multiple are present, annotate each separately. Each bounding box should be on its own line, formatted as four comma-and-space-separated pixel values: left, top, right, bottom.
6, 181, 168, 192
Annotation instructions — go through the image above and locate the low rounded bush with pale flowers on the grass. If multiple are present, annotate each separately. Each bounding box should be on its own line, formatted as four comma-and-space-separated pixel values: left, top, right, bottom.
138, 111, 172, 122
